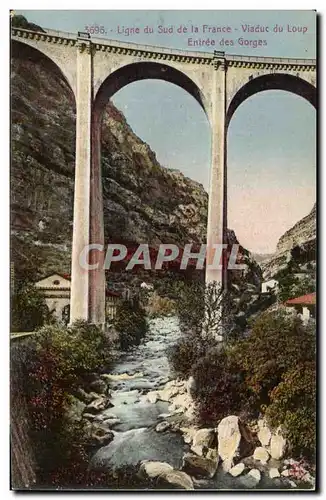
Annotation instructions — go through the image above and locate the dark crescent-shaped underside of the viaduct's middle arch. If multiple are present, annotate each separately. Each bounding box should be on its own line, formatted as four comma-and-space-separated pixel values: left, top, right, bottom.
94, 61, 207, 120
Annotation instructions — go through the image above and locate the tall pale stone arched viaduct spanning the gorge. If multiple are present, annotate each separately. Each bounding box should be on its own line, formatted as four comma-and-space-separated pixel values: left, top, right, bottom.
11, 28, 317, 325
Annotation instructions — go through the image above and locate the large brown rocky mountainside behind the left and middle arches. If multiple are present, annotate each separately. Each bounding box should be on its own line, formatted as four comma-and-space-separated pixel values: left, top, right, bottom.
11, 16, 260, 292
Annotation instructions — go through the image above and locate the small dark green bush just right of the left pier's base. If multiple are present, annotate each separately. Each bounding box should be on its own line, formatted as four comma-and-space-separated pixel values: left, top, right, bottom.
114, 299, 148, 349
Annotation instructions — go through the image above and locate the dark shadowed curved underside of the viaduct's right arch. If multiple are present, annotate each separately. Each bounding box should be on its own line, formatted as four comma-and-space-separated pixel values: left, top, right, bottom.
226, 73, 317, 127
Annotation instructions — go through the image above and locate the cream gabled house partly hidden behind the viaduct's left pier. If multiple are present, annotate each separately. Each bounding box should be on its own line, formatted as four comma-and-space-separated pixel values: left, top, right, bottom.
35, 273, 122, 323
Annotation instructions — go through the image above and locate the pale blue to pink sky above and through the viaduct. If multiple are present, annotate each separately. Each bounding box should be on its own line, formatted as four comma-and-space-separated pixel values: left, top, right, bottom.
16, 10, 316, 253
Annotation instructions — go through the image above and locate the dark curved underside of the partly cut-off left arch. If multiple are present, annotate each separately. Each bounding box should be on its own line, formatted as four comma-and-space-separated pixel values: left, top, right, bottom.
11, 40, 76, 109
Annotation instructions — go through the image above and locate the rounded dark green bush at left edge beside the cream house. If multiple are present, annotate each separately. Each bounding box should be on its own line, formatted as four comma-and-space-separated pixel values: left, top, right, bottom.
11, 283, 52, 332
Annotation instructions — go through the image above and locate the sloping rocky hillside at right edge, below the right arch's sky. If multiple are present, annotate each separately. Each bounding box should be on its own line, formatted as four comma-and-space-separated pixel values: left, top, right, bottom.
261, 204, 316, 278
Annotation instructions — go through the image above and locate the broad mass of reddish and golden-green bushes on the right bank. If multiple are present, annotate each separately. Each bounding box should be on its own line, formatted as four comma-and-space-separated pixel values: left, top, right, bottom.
169, 309, 316, 456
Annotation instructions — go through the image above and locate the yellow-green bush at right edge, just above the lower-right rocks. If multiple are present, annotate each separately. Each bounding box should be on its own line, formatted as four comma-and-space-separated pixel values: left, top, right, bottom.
266, 361, 316, 458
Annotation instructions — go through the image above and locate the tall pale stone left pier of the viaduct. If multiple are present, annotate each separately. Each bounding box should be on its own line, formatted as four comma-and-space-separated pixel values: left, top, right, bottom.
70, 40, 105, 325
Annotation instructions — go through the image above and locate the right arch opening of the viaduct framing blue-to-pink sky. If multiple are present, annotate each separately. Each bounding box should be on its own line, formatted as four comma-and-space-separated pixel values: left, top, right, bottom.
227, 79, 316, 255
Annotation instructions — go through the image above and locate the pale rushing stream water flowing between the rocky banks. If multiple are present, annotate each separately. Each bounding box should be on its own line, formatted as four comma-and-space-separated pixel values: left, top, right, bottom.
92, 317, 288, 489
